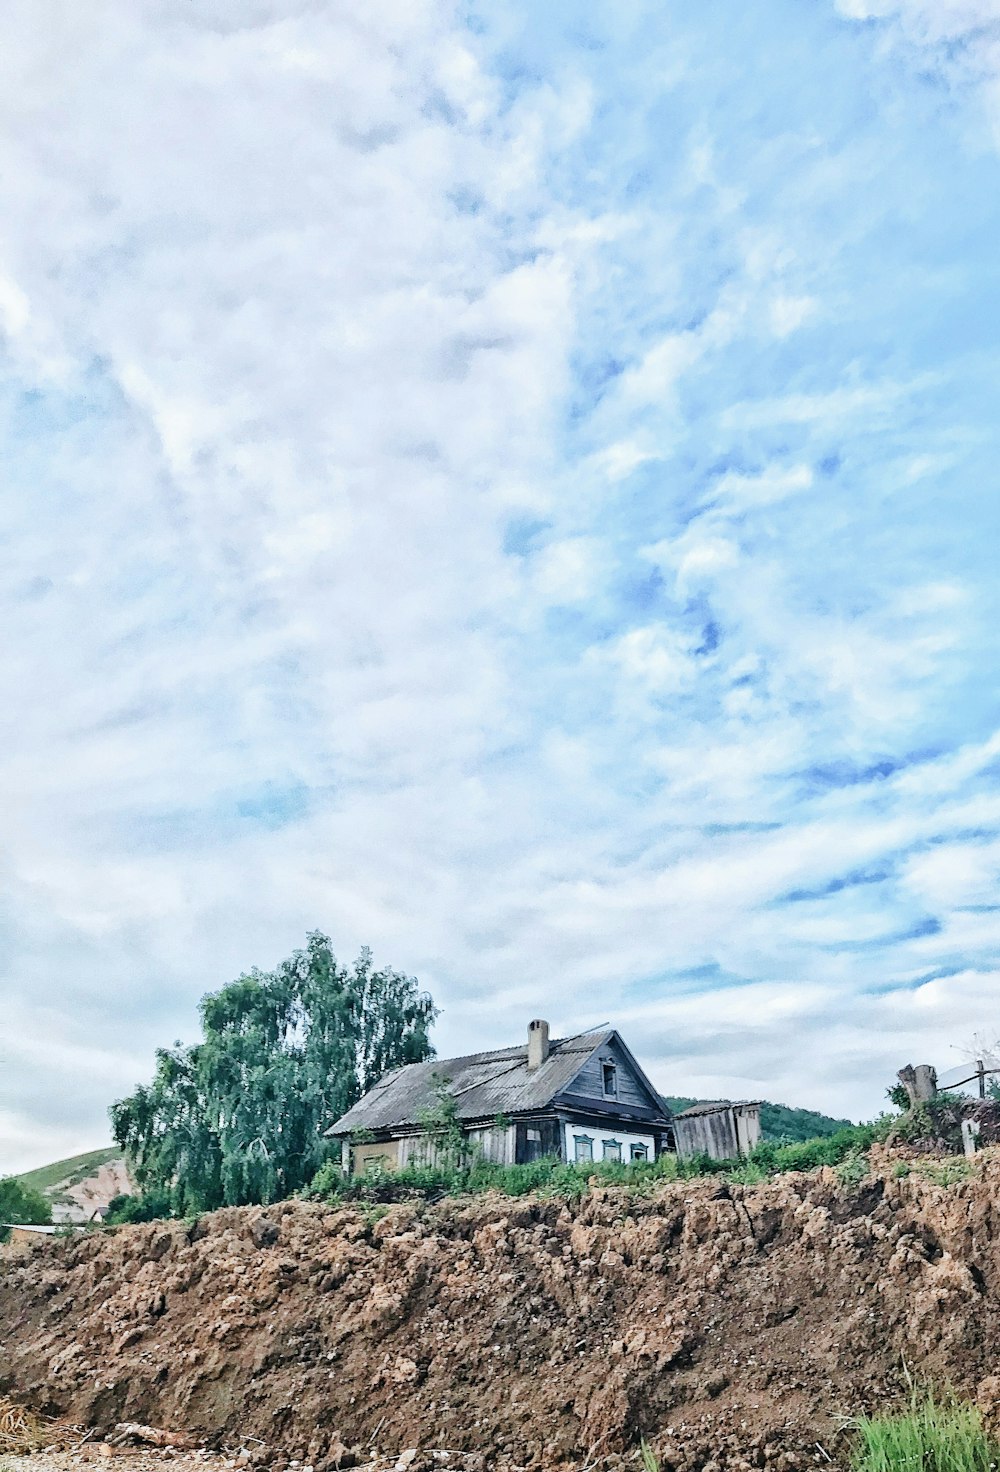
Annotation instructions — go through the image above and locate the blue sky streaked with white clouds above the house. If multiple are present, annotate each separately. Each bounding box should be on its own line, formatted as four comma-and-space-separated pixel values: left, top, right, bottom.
0, 0, 1000, 1170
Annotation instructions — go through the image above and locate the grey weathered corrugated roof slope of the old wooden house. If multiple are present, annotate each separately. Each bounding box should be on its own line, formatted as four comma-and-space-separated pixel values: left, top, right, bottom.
327, 1027, 614, 1135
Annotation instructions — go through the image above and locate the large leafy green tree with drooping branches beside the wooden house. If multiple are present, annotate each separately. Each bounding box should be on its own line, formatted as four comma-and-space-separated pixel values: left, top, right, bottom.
110, 930, 437, 1213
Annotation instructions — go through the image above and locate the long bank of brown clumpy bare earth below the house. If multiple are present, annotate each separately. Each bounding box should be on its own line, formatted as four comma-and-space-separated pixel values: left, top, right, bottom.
0, 1154, 1000, 1472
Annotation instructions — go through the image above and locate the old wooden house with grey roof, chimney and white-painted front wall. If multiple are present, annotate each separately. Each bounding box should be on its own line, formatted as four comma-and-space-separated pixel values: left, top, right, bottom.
328, 1022, 673, 1172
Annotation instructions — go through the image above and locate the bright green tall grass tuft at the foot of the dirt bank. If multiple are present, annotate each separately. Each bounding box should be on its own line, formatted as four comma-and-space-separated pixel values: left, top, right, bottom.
851, 1390, 1000, 1472
